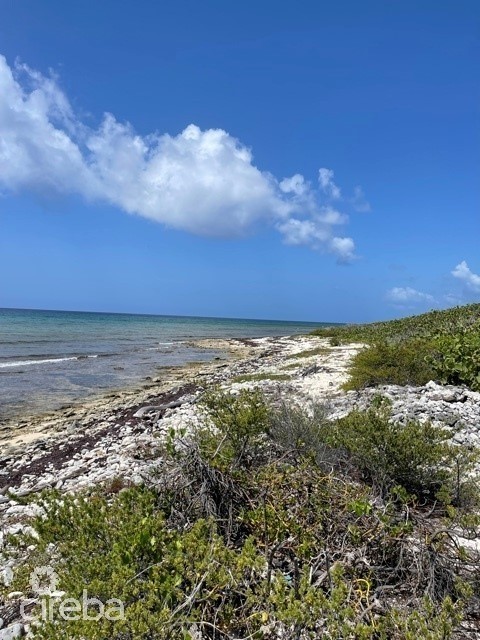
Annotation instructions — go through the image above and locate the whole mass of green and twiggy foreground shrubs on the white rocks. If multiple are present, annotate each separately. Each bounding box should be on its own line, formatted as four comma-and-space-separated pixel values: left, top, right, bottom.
9, 390, 480, 640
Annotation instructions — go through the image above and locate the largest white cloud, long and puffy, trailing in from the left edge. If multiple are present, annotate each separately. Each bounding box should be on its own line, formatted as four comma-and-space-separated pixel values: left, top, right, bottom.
0, 56, 364, 261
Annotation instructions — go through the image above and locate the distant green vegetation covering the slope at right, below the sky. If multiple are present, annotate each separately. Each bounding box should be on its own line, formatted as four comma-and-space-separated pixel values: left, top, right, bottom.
313, 304, 480, 391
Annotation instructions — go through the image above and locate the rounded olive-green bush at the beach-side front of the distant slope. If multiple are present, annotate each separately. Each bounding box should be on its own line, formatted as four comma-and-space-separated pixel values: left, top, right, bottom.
344, 340, 435, 389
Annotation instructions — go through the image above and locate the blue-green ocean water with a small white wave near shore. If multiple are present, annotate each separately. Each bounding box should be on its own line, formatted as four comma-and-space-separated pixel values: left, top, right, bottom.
0, 309, 338, 420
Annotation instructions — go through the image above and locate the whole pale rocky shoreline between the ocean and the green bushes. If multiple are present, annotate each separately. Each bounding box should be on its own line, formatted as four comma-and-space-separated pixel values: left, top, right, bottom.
0, 336, 480, 640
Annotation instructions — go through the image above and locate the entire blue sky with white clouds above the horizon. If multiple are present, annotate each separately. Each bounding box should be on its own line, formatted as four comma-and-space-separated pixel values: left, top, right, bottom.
0, 0, 480, 322
